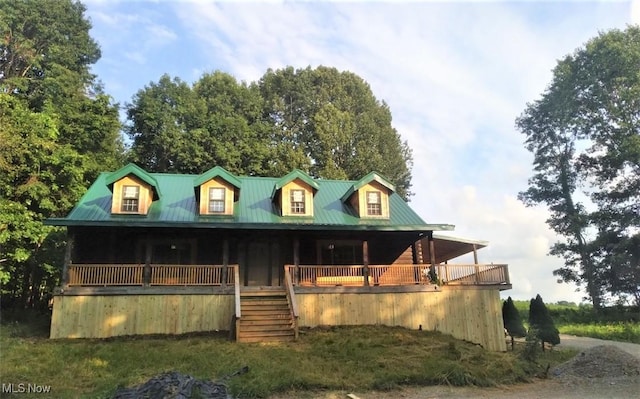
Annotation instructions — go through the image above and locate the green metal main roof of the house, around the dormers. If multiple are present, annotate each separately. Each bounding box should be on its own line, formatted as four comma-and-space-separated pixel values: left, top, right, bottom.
47, 173, 453, 231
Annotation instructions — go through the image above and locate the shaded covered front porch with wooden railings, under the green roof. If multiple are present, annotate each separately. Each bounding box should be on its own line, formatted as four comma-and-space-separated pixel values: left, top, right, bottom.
61, 228, 510, 292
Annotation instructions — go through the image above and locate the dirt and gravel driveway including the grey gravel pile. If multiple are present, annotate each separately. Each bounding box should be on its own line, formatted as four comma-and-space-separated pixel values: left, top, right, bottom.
272, 335, 640, 399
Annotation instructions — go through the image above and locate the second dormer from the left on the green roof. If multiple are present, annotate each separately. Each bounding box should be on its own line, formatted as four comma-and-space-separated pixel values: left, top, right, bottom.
193, 166, 240, 216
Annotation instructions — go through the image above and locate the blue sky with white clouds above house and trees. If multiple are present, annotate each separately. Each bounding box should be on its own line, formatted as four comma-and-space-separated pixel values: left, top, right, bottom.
84, 0, 640, 303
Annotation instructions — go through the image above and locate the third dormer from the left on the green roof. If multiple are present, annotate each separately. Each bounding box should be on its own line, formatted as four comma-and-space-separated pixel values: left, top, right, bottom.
271, 169, 320, 217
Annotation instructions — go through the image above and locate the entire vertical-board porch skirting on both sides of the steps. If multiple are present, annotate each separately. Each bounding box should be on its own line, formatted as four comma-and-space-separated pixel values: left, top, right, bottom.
51, 287, 506, 351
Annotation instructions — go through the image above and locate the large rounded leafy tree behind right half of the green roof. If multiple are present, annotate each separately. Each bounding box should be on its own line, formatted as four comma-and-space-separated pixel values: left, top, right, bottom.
258, 66, 412, 198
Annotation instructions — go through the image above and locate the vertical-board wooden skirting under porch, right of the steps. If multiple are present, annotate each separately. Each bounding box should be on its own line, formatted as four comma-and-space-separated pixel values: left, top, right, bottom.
296, 289, 507, 351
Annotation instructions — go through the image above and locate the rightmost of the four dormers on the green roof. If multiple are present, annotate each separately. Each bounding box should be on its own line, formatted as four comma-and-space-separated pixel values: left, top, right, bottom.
341, 172, 395, 219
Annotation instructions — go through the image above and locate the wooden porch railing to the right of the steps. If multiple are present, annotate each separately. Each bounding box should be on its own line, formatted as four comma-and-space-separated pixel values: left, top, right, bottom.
285, 264, 509, 286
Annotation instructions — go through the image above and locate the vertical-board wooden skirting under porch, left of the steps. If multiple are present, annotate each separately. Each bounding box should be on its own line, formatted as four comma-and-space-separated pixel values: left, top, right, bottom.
50, 295, 235, 338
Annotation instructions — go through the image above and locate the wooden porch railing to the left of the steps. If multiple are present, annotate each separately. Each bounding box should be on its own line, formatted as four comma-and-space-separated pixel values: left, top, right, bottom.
67, 264, 237, 287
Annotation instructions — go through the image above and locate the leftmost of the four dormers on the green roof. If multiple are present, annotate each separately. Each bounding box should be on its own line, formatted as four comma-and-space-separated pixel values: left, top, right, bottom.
105, 163, 160, 215
